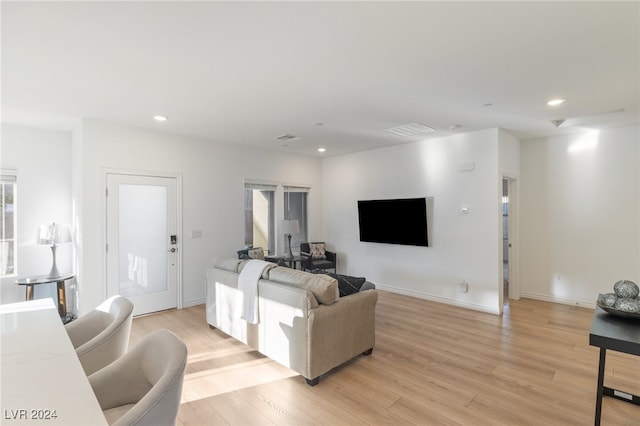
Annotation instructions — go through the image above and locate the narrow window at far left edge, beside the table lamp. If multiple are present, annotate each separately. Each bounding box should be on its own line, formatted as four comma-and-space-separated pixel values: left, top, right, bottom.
0, 172, 16, 277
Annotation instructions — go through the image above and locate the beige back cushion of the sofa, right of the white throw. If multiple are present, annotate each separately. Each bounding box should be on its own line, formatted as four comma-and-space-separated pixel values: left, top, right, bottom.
269, 266, 340, 305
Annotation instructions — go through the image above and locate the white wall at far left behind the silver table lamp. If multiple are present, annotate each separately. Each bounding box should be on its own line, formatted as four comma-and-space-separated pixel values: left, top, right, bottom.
0, 124, 73, 309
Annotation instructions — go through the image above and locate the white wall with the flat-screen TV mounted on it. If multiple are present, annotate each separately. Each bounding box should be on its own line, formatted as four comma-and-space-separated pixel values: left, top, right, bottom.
323, 129, 504, 313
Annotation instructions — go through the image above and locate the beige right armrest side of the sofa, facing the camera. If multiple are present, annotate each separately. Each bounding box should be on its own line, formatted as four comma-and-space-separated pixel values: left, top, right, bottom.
301, 290, 378, 379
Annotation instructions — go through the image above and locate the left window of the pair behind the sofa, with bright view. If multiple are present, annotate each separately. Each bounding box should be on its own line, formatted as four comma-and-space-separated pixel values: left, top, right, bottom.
244, 183, 276, 254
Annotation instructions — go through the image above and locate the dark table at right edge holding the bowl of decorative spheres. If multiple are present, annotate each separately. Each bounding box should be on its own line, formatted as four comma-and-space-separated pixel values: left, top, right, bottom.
589, 307, 640, 426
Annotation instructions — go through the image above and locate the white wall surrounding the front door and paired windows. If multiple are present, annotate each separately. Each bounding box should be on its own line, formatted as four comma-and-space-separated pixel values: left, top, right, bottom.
73, 120, 322, 312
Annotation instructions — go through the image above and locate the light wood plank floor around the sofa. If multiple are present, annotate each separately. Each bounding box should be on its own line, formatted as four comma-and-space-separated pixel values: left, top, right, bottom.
131, 291, 640, 426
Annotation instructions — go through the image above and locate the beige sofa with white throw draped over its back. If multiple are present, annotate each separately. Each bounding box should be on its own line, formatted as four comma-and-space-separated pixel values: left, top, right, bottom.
207, 258, 378, 386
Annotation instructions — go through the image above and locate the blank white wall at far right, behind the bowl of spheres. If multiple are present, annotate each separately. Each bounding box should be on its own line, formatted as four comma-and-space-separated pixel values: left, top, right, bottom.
520, 126, 640, 306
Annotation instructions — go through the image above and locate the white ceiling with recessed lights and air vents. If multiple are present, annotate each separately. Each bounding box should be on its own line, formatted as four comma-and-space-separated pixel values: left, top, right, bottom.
1, 1, 640, 156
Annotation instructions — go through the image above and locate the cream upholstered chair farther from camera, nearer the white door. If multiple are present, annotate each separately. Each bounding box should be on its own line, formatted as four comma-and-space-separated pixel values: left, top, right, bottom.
65, 296, 133, 376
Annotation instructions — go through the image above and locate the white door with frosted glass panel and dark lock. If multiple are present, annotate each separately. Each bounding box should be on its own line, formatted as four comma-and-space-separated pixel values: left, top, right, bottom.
106, 173, 180, 315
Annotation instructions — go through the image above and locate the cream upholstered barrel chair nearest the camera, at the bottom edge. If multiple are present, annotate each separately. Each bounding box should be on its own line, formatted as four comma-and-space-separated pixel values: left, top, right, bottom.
89, 329, 187, 426
